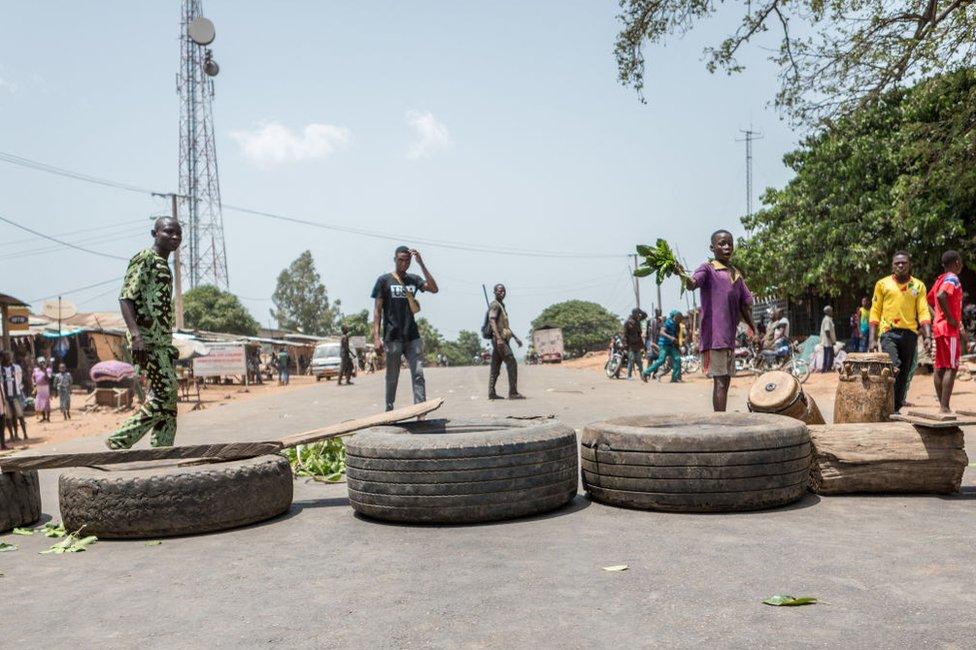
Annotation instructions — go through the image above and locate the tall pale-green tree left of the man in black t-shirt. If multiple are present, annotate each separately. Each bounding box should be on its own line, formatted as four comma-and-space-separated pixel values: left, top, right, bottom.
271, 251, 339, 336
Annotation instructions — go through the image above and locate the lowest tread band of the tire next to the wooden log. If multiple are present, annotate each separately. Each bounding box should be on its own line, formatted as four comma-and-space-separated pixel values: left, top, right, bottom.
587, 481, 807, 512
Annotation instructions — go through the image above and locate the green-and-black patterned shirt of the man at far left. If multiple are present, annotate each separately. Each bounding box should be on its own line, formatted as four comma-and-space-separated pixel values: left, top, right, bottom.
119, 248, 173, 346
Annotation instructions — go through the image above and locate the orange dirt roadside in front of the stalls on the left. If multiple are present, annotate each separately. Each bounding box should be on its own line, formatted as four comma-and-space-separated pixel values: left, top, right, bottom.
0, 375, 350, 455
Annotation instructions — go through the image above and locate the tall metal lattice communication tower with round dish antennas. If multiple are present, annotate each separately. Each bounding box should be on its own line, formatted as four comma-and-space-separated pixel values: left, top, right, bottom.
177, 0, 229, 289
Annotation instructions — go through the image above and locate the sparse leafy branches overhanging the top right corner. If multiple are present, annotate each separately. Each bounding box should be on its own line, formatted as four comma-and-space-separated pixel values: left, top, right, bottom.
615, 0, 976, 123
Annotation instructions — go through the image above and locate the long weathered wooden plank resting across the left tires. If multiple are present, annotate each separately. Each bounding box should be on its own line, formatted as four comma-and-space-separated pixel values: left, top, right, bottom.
0, 398, 444, 472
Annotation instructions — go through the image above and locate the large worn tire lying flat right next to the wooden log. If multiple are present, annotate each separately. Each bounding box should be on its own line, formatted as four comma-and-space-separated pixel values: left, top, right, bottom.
581, 413, 812, 512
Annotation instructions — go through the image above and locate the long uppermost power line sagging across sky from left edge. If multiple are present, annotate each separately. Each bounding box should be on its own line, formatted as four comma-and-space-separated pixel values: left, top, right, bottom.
0, 151, 625, 259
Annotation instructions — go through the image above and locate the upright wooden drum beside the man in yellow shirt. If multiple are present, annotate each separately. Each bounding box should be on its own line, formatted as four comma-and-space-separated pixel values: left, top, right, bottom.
834, 352, 895, 424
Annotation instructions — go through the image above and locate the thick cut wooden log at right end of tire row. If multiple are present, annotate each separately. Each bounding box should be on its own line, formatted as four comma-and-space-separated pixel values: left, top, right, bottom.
810, 422, 969, 494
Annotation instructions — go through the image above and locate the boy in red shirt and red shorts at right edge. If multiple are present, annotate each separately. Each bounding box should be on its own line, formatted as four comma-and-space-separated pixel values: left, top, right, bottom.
928, 251, 963, 413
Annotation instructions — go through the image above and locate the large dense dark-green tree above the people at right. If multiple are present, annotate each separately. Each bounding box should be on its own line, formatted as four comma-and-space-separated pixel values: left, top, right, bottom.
736, 69, 976, 296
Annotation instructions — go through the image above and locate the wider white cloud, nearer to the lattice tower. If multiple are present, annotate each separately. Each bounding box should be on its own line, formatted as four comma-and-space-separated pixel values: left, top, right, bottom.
230, 122, 352, 167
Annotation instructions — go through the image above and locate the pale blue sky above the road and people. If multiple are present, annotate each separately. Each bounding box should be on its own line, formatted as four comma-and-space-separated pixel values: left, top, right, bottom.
0, 0, 799, 337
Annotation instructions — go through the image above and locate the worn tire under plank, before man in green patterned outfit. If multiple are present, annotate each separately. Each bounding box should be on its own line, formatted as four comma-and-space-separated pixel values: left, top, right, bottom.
58, 454, 294, 538
